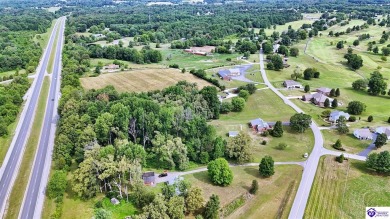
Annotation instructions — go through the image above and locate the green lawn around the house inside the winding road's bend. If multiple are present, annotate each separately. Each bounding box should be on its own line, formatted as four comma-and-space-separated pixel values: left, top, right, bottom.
211, 89, 314, 162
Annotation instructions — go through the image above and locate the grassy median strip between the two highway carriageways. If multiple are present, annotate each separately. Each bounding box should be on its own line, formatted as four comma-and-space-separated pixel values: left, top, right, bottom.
5, 77, 50, 218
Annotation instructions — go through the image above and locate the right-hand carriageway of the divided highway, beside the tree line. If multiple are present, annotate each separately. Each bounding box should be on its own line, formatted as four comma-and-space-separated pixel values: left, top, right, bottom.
19, 17, 65, 218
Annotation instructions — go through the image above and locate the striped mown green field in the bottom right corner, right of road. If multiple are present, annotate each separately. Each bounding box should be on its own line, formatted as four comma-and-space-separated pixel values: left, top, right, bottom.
304, 156, 390, 219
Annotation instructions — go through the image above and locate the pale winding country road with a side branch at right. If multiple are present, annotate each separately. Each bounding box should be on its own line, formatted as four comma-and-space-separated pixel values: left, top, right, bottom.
259, 50, 366, 219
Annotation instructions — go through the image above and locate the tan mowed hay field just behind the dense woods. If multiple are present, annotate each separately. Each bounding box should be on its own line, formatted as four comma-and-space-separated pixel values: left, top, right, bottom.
80, 69, 211, 92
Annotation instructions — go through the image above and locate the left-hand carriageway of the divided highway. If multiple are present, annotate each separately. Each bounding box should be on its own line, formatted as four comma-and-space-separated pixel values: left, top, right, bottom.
0, 21, 59, 217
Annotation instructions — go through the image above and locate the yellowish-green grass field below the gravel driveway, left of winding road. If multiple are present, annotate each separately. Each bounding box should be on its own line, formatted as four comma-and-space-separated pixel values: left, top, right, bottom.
185, 165, 302, 218
